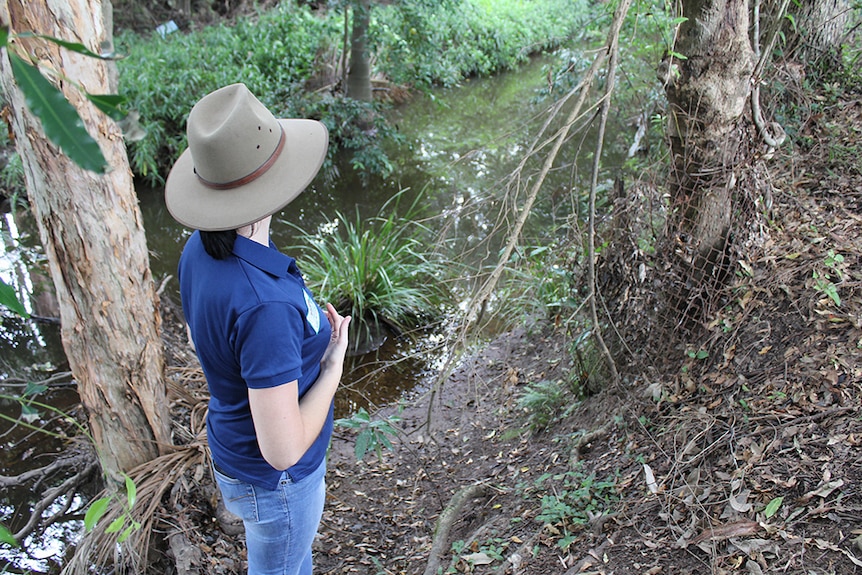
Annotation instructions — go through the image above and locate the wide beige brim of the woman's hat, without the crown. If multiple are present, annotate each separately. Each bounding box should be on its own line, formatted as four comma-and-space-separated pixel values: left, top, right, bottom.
165, 118, 329, 232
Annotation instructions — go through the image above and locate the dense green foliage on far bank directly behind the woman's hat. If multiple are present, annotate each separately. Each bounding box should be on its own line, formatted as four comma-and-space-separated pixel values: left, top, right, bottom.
117, 2, 342, 184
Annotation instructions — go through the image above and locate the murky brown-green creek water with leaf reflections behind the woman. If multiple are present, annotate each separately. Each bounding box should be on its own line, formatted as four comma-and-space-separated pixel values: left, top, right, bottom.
0, 54, 630, 573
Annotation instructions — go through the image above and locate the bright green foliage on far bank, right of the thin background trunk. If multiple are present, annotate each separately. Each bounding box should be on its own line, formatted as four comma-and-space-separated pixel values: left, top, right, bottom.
369, 0, 586, 88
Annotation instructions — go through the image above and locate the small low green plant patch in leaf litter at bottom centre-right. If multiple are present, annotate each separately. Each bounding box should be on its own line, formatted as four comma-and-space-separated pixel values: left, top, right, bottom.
535, 466, 620, 551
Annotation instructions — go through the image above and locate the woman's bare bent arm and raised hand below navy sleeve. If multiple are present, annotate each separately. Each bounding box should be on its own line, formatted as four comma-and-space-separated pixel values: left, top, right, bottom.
248, 304, 350, 469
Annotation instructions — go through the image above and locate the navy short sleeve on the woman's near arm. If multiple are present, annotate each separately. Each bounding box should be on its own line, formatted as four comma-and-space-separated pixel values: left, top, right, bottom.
234, 302, 305, 388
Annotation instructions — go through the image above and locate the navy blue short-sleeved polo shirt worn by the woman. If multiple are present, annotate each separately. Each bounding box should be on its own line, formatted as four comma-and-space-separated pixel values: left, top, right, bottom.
179, 232, 333, 489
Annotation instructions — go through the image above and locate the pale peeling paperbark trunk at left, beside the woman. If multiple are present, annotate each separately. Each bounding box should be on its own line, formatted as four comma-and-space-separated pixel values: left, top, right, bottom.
0, 0, 170, 480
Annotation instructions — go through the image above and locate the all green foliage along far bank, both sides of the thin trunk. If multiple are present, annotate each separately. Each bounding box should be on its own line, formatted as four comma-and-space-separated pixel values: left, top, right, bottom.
117, 0, 600, 185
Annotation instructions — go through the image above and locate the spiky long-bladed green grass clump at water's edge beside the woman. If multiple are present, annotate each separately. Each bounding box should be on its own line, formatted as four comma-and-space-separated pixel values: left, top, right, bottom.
294, 192, 449, 352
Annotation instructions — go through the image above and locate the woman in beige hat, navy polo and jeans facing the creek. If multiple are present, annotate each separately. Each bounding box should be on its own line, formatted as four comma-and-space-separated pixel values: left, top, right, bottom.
165, 84, 350, 575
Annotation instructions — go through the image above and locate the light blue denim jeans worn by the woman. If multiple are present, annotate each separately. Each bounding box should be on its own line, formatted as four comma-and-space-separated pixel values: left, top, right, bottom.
215, 460, 326, 575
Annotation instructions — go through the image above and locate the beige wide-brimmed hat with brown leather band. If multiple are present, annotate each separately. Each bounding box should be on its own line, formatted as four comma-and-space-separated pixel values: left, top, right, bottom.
165, 84, 329, 231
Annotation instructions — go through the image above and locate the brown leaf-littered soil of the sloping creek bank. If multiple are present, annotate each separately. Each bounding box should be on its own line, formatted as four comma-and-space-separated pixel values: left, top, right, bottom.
155, 84, 862, 575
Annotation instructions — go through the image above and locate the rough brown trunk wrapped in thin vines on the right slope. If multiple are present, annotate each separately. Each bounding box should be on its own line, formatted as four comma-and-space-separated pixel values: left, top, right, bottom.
661, 0, 754, 332
